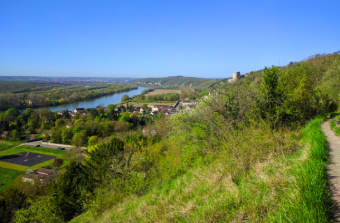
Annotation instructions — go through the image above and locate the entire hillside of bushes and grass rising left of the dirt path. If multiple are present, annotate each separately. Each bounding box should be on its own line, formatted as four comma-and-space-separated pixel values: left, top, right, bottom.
7, 53, 340, 222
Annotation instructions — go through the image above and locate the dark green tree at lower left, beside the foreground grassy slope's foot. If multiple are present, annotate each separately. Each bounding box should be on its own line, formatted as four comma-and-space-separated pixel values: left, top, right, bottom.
51, 160, 94, 221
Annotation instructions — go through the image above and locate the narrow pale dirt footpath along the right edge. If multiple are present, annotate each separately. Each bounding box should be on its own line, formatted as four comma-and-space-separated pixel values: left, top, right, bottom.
321, 119, 340, 222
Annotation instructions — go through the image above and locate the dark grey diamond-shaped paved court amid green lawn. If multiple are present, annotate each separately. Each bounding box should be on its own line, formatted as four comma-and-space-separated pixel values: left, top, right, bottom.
0, 152, 56, 166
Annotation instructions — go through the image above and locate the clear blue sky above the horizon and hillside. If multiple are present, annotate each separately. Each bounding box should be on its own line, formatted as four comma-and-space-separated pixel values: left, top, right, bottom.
0, 0, 340, 78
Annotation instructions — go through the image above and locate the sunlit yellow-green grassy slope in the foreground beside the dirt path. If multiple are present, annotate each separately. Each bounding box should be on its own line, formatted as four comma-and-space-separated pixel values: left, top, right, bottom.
72, 118, 332, 222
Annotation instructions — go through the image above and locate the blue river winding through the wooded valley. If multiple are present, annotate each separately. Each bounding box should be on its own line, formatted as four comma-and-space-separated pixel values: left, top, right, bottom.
38, 87, 146, 112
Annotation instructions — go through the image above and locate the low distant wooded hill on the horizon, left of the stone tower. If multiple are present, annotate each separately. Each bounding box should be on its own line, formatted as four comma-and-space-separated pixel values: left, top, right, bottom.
131, 76, 227, 90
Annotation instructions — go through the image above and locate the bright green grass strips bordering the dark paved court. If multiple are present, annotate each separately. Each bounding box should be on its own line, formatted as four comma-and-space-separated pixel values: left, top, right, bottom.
0, 146, 66, 171
